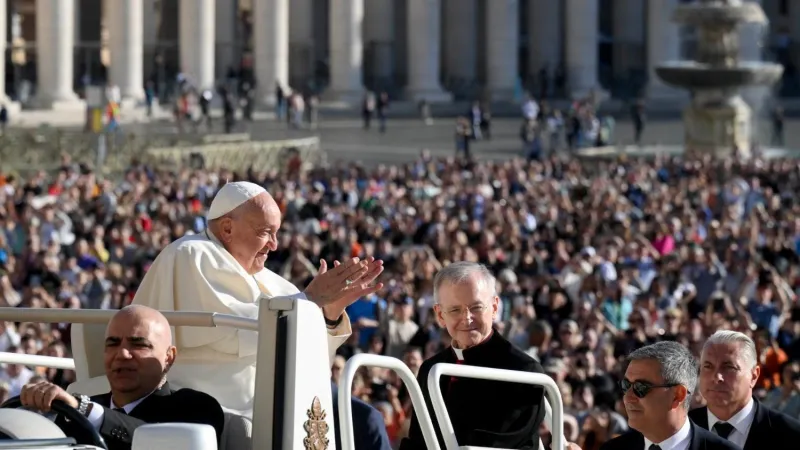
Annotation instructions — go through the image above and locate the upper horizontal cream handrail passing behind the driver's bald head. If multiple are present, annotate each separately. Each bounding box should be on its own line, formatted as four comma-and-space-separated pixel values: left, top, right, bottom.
0, 307, 258, 331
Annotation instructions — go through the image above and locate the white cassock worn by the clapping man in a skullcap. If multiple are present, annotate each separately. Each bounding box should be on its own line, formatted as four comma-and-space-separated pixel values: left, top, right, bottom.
133, 231, 351, 417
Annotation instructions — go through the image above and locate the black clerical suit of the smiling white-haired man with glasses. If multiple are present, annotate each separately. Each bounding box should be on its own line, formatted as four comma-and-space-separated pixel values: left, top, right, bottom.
400, 331, 545, 450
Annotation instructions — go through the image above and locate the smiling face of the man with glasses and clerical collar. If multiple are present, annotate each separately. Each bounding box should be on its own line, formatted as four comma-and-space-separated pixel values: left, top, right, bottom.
435, 276, 500, 349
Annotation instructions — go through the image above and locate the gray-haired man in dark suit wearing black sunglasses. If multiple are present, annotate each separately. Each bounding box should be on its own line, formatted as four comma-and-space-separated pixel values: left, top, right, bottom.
600, 341, 738, 450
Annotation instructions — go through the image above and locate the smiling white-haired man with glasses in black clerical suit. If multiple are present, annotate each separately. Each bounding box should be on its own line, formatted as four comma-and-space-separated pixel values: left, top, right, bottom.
400, 262, 545, 450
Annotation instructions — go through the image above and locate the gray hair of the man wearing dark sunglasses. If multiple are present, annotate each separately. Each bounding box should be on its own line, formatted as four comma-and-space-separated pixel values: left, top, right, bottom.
628, 341, 698, 410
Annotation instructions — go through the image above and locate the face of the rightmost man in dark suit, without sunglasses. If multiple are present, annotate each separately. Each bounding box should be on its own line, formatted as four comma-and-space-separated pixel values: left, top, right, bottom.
700, 343, 761, 414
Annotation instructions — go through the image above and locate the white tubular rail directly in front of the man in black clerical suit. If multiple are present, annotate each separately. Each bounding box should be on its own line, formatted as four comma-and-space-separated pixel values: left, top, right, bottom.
428, 363, 567, 450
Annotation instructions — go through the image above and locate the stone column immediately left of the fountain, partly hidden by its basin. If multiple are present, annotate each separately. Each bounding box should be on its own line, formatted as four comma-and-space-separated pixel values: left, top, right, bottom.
647, 0, 685, 99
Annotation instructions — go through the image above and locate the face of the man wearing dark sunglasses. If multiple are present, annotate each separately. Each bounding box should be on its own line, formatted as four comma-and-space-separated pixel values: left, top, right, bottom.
622, 359, 688, 435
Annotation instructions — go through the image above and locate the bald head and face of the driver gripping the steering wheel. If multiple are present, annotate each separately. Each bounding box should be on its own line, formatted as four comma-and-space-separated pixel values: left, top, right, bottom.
104, 311, 176, 406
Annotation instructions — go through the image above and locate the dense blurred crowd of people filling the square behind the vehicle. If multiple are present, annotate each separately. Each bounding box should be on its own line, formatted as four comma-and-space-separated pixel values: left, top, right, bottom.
0, 147, 800, 449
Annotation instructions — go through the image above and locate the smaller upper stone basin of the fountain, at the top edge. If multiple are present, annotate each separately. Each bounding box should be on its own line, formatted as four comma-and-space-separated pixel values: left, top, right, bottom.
672, 2, 768, 27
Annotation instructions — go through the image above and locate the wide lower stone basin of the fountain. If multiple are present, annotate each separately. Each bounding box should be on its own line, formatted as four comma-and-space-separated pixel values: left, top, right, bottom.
656, 61, 783, 90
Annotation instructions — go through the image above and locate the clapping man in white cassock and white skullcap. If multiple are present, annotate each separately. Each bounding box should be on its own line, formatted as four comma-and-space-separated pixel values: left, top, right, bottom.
133, 182, 383, 417
